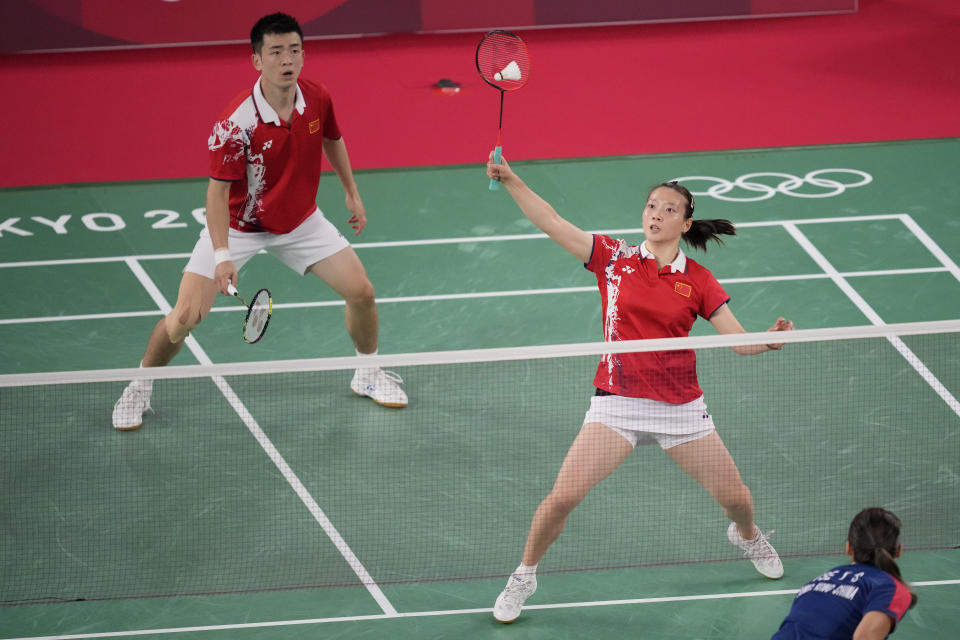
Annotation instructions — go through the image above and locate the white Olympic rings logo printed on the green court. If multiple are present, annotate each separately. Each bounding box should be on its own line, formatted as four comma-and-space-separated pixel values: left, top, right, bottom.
674, 169, 873, 202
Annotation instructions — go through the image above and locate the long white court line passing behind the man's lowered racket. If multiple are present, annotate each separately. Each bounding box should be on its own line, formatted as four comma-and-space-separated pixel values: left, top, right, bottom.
0, 266, 950, 325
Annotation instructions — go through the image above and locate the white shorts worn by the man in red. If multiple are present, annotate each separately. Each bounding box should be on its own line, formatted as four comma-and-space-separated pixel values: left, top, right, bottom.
183, 209, 350, 278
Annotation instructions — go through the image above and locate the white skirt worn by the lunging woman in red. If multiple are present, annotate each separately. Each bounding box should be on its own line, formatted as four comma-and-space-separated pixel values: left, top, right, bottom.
583, 395, 715, 449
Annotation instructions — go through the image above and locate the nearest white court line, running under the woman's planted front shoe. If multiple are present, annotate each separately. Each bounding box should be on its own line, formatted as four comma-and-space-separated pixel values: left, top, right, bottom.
6, 580, 960, 640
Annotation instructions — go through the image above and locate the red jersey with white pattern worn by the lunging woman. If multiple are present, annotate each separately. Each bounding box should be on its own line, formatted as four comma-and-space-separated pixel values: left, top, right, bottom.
584, 235, 730, 404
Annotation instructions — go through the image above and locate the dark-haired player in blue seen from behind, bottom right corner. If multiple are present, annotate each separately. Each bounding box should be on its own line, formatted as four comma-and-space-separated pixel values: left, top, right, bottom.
772, 507, 917, 640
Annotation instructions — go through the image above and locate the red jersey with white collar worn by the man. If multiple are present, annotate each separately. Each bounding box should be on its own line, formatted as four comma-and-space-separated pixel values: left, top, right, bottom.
207, 79, 340, 233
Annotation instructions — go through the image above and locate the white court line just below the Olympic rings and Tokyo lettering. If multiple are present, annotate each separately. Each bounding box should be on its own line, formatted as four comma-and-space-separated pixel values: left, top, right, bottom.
0, 213, 916, 268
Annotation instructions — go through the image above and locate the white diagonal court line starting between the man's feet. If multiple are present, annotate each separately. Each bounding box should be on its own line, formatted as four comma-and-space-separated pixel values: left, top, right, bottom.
126, 258, 397, 615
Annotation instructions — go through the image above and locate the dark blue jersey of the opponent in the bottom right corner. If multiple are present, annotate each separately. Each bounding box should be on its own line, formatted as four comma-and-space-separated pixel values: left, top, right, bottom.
771, 564, 910, 640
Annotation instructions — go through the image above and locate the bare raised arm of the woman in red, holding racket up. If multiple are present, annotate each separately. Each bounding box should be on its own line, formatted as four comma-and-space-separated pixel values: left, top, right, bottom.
487, 151, 593, 262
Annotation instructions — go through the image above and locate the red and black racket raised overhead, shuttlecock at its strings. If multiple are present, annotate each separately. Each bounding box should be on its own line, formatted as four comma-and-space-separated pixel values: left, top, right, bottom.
477, 29, 530, 191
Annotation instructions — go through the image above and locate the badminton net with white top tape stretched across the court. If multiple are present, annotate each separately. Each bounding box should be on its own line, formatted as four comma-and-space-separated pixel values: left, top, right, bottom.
0, 321, 960, 604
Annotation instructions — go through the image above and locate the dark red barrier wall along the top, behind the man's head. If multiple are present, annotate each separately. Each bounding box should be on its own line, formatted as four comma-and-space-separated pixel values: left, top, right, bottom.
0, 0, 857, 51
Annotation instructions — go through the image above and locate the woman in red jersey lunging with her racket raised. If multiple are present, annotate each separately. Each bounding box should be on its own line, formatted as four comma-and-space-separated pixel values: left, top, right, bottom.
487, 153, 793, 622
